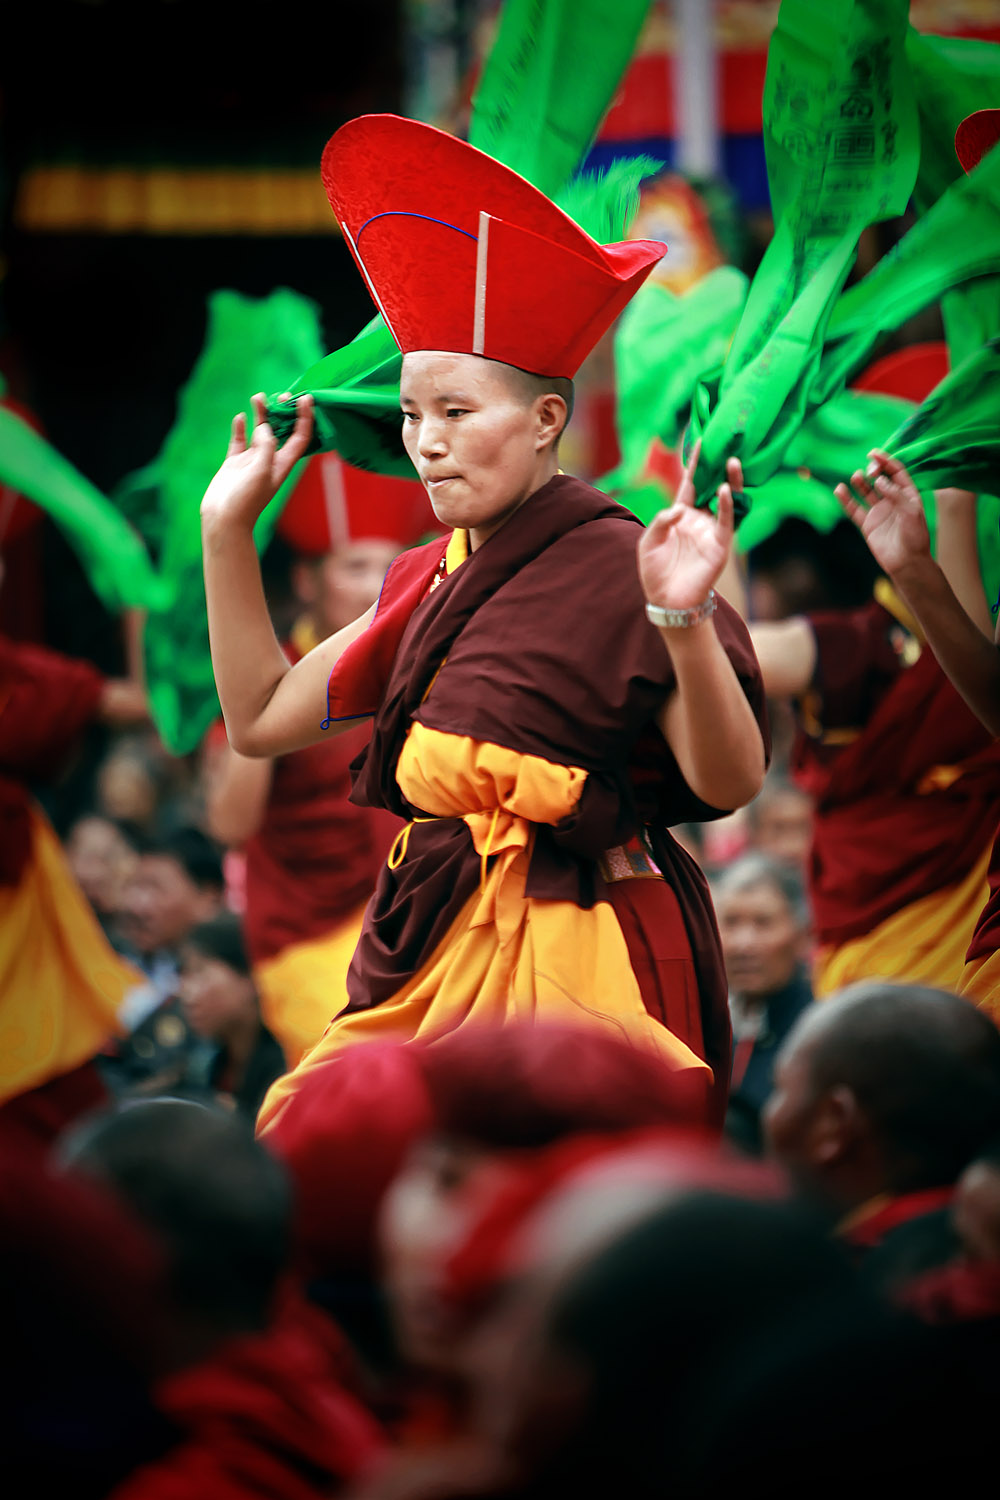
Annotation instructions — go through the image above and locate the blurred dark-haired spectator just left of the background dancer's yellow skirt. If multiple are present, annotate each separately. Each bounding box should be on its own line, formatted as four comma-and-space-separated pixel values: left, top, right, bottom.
178, 912, 285, 1121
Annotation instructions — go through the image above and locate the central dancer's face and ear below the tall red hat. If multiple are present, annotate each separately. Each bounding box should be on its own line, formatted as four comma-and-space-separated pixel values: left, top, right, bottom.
400, 350, 554, 549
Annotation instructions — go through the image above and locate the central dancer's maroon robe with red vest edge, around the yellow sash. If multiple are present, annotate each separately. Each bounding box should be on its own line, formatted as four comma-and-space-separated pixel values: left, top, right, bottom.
330, 474, 768, 1077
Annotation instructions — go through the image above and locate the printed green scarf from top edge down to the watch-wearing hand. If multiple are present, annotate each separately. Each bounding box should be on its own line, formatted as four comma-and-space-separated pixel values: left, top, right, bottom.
690, 0, 919, 501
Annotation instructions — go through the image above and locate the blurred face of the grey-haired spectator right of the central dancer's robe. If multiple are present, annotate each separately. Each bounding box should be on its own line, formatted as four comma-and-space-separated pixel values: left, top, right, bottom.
715, 881, 807, 999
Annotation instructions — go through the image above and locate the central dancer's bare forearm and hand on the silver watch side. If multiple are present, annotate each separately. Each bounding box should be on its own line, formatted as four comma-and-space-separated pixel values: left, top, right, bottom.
639, 444, 765, 809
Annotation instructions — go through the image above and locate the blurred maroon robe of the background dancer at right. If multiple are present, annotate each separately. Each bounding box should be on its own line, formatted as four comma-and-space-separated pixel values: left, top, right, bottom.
793, 600, 1000, 944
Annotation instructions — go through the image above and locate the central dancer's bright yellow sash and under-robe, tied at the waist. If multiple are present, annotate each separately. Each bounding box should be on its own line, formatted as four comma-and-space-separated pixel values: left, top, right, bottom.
258, 723, 712, 1131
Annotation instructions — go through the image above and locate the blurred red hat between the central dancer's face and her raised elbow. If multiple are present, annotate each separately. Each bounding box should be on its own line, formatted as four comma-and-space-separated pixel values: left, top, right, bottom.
276, 453, 441, 557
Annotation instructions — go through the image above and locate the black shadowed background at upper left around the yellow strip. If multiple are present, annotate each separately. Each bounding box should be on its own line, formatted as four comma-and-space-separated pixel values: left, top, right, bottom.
0, 0, 405, 669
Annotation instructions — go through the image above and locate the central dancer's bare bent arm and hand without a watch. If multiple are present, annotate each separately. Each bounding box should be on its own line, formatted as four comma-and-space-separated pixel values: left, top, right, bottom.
201, 395, 375, 756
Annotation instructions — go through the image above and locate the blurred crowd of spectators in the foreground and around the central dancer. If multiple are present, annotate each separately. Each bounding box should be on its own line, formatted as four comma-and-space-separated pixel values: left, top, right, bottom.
0, 489, 1000, 1500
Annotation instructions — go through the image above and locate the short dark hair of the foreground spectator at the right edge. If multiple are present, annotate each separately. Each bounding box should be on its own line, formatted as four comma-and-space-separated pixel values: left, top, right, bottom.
792, 980, 1000, 1193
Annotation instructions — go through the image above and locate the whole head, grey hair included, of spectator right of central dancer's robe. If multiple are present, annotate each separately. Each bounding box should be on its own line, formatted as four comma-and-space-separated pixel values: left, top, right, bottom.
712, 854, 810, 1004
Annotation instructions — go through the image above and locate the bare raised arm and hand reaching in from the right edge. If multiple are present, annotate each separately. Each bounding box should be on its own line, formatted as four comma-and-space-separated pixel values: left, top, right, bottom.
837, 449, 1000, 735
